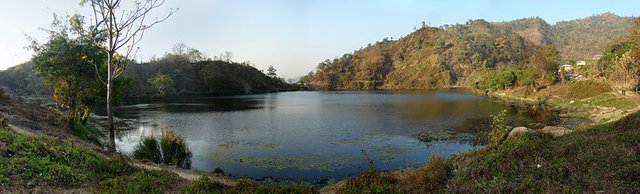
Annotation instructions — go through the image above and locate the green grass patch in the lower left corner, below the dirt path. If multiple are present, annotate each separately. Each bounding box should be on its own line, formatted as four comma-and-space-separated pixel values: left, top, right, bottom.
0, 128, 188, 192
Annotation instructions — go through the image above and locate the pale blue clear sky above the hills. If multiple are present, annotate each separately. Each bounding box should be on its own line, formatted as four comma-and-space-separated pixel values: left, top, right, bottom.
0, 0, 640, 78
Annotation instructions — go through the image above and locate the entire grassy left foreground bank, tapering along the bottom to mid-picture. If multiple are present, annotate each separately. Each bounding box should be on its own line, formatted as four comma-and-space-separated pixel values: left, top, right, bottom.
0, 127, 314, 193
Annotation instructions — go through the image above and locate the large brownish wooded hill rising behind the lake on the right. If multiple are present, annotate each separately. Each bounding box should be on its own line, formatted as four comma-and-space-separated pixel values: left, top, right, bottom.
302, 13, 634, 89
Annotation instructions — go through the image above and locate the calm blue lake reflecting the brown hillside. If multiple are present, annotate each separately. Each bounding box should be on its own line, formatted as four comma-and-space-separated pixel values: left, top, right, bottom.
96, 89, 560, 183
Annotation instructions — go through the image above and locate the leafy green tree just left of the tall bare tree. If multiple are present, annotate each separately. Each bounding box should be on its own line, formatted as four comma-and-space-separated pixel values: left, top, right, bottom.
30, 23, 106, 129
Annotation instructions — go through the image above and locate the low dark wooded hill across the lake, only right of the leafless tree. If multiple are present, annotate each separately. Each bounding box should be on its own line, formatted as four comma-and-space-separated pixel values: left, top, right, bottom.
125, 56, 294, 97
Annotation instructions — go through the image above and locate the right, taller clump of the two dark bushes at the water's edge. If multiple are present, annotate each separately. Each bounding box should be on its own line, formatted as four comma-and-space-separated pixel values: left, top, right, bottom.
160, 129, 192, 168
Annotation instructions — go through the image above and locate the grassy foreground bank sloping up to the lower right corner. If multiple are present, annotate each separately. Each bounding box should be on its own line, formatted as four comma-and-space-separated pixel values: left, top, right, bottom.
324, 101, 640, 193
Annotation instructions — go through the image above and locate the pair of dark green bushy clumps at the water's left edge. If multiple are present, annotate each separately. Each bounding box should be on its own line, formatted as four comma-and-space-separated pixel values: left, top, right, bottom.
133, 129, 192, 169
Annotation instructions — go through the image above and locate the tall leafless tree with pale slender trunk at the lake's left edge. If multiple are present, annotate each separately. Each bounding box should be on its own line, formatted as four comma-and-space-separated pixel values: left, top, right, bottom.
78, 0, 177, 153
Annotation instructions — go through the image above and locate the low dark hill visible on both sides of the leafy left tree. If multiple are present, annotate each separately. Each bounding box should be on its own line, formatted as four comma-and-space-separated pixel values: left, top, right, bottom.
0, 55, 294, 97
